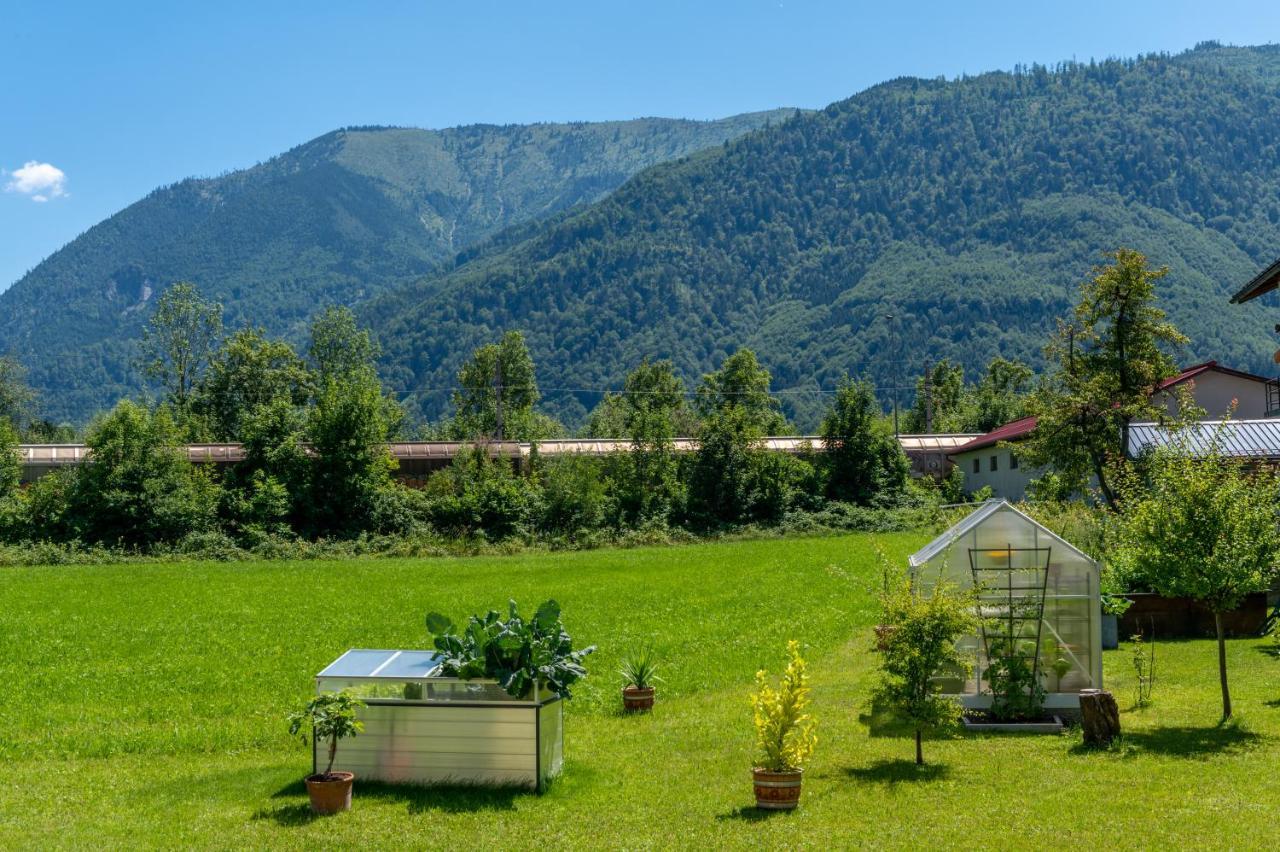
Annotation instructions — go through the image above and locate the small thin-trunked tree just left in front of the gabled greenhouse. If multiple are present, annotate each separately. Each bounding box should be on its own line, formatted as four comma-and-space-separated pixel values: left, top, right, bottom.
876, 570, 977, 766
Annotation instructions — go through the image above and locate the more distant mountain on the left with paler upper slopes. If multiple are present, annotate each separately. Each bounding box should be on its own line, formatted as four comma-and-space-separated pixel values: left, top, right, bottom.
0, 110, 795, 420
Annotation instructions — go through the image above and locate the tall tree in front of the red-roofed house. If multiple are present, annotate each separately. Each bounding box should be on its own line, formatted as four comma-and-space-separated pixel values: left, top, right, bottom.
1019, 248, 1187, 508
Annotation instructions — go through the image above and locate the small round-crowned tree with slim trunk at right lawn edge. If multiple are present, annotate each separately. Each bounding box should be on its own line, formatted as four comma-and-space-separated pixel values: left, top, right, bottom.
1112, 440, 1280, 719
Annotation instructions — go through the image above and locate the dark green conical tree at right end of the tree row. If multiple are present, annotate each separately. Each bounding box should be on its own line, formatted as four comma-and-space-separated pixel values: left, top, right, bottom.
822, 377, 911, 505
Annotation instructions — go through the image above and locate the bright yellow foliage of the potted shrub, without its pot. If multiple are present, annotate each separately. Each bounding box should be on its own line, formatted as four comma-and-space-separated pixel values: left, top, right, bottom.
751, 640, 818, 771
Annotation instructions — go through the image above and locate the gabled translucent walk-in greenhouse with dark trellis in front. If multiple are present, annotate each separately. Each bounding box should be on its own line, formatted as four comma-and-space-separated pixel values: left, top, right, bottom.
910, 499, 1102, 710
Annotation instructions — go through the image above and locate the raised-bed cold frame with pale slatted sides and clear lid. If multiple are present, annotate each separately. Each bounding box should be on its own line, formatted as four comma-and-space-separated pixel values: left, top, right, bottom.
316, 649, 564, 789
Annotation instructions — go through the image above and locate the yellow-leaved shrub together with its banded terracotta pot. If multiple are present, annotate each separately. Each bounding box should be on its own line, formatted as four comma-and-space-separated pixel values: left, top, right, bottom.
751, 640, 818, 810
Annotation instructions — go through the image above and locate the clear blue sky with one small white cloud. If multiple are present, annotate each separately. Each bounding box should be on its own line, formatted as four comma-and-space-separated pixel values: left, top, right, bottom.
0, 0, 1280, 289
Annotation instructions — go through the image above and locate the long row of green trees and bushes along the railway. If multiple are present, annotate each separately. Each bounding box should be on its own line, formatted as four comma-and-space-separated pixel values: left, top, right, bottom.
0, 284, 909, 549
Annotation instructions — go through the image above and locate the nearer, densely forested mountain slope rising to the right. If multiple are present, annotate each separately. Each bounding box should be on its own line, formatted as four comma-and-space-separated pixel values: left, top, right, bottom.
365, 43, 1280, 427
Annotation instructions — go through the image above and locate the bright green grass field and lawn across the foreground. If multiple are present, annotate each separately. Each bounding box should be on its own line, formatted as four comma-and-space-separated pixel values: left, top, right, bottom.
0, 533, 1280, 848
